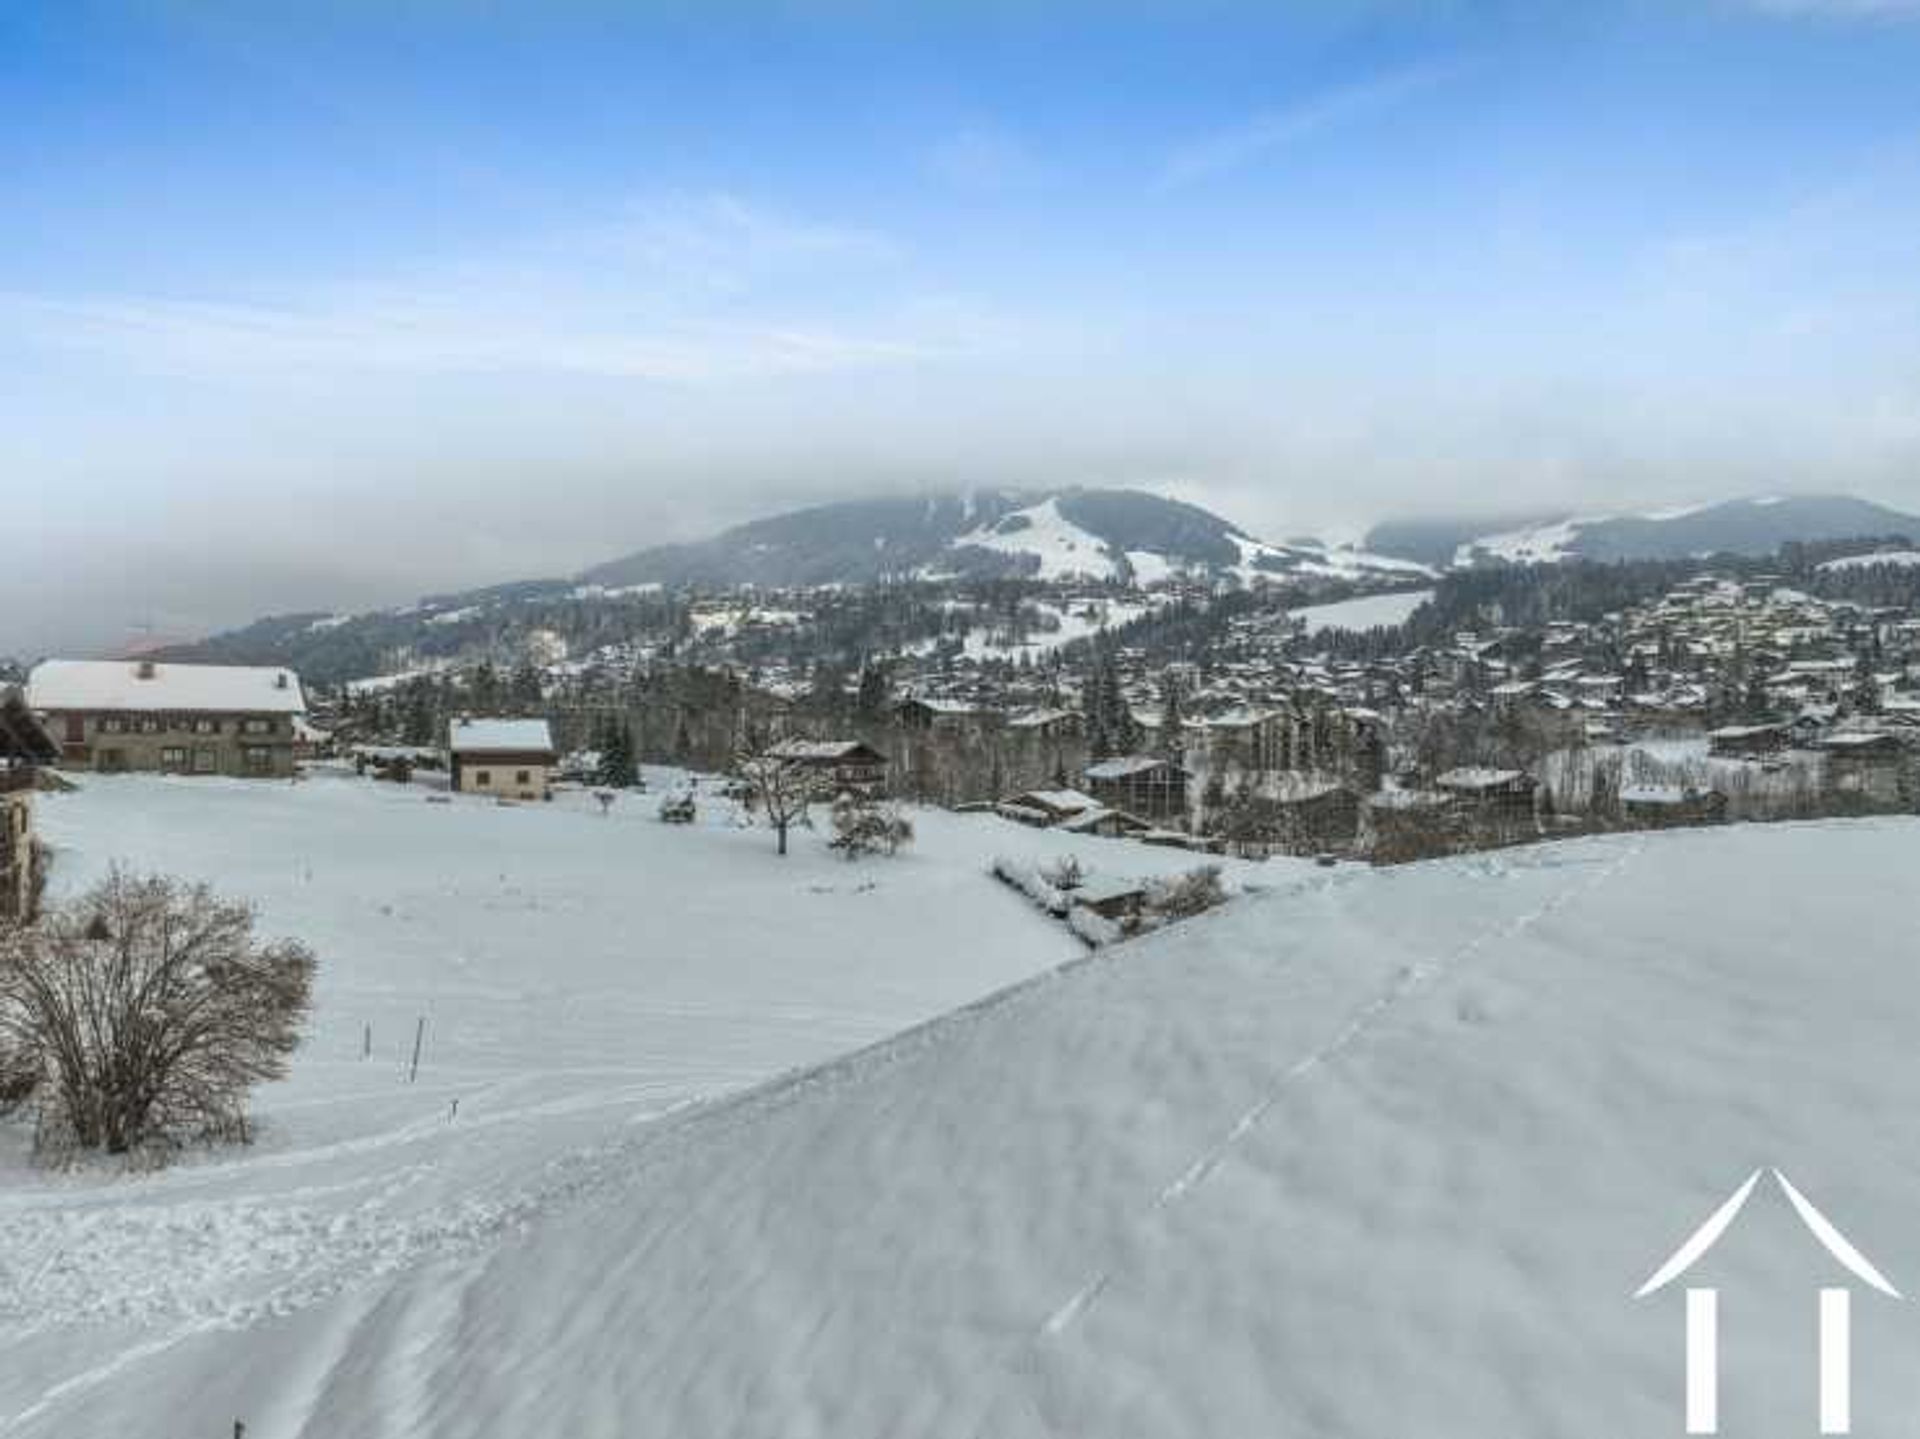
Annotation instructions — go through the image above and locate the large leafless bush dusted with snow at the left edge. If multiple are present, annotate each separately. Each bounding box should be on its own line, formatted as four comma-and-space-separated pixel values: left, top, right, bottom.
0, 870, 315, 1153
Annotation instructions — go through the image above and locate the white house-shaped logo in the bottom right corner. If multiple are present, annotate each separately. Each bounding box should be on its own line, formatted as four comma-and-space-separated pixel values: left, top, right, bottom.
1634, 1170, 1901, 1433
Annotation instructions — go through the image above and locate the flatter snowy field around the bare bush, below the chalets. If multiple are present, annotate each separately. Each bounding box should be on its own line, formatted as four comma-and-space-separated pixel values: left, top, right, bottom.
0, 772, 1300, 1435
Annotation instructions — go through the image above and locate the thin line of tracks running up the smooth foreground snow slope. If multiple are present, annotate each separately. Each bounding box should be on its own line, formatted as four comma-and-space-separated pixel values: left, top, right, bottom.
972, 843, 1644, 1439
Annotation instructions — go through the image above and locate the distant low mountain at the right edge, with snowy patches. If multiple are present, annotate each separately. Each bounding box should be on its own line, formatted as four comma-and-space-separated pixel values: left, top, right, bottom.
1367, 496, 1920, 569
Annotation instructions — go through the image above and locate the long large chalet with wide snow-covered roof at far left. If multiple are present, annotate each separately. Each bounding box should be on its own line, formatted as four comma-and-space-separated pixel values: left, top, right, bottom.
27, 659, 307, 778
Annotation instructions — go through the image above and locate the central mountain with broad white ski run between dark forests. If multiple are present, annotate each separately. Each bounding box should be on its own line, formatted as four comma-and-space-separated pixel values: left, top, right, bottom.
580, 488, 1423, 588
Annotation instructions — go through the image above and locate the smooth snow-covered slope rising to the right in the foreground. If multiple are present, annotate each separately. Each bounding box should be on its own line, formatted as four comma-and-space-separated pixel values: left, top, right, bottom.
11, 820, 1920, 1439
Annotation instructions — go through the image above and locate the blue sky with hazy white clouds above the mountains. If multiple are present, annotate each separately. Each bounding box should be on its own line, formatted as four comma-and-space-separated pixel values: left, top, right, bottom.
0, 0, 1920, 651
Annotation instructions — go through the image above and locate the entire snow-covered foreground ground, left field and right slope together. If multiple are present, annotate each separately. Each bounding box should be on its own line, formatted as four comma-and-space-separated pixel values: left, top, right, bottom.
0, 782, 1920, 1439
